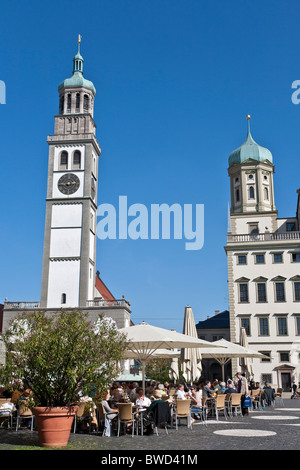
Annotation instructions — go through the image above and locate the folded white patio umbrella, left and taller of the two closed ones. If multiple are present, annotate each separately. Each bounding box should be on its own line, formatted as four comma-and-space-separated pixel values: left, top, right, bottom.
181, 306, 202, 383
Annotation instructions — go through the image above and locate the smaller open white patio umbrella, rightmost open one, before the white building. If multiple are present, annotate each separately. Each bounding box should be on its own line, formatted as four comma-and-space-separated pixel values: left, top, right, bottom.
197, 339, 266, 381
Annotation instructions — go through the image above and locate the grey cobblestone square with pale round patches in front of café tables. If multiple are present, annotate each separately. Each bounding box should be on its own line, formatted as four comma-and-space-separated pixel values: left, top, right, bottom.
0, 399, 300, 454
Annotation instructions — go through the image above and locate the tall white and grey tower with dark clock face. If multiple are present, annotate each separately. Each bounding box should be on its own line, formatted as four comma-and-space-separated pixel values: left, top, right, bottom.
41, 36, 101, 308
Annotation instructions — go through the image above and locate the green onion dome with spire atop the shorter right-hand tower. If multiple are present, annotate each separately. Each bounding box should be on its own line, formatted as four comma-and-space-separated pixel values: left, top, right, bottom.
228, 118, 273, 166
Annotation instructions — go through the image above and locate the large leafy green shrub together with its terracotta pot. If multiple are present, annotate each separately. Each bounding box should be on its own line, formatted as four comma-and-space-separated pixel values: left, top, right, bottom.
1, 310, 126, 447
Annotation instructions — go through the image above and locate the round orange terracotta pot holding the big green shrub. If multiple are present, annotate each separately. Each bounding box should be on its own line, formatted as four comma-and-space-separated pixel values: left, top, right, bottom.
32, 406, 78, 447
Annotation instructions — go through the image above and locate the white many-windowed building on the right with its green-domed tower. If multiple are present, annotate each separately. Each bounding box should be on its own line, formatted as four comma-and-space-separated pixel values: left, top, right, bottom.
225, 116, 300, 391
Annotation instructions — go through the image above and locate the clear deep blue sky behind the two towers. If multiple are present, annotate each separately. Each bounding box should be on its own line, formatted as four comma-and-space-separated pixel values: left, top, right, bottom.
0, 0, 300, 331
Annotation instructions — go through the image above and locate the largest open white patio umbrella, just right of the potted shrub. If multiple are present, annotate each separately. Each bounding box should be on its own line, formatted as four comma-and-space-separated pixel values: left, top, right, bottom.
119, 322, 216, 390
